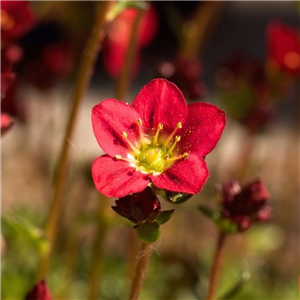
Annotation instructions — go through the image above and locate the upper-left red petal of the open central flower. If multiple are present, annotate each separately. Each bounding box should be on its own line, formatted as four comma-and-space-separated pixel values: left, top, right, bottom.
92, 99, 140, 157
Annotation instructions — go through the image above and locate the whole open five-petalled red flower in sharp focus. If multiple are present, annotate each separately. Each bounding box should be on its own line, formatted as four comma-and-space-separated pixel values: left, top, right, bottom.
92, 79, 226, 197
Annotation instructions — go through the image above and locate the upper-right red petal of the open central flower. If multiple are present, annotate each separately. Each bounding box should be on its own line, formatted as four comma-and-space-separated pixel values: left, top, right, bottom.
180, 102, 226, 156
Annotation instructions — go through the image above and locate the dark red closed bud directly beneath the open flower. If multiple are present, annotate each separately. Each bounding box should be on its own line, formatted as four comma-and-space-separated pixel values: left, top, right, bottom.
112, 187, 160, 223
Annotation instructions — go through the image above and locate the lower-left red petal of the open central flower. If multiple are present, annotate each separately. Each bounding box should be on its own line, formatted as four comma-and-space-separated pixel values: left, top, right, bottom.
92, 155, 149, 198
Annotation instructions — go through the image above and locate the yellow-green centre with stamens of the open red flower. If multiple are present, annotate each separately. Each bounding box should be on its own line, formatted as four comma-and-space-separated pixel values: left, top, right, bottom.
116, 119, 188, 175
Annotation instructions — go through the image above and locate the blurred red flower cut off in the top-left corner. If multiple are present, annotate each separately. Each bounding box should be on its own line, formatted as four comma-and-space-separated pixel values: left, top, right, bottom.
0, 0, 36, 48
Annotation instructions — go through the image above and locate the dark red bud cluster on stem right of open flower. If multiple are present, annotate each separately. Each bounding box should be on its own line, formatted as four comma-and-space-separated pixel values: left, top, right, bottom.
221, 180, 271, 231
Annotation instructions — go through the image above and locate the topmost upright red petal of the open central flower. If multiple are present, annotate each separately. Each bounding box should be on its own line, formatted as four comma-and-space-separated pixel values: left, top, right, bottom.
132, 79, 187, 129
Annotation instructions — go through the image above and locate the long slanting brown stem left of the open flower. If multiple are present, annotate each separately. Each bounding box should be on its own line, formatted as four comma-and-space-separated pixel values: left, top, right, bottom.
37, 0, 110, 280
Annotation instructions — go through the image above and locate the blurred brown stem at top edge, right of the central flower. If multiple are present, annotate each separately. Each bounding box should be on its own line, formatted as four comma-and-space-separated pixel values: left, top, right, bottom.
180, 0, 223, 58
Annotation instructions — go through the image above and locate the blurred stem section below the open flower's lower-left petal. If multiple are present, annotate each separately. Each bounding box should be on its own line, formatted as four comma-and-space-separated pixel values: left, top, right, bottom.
87, 194, 108, 300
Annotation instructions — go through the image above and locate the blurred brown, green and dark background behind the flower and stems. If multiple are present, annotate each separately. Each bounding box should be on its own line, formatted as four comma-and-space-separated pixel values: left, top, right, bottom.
1, 0, 300, 300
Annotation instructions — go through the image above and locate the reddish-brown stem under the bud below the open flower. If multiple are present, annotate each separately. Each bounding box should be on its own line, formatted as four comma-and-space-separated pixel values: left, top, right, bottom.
129, 243, 151, 300
